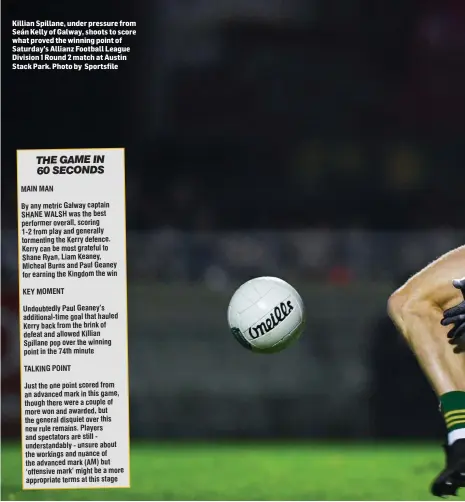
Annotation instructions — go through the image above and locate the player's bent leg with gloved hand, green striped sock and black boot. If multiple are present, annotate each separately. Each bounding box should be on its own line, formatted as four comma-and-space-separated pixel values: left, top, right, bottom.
388, 246, 465, 497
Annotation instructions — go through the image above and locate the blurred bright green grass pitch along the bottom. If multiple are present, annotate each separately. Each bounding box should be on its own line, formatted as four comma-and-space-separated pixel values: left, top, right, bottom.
1, 442, 465, 500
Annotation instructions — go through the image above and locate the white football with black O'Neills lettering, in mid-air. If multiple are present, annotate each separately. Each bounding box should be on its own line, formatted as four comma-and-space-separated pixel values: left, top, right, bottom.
228, 277, 305, 353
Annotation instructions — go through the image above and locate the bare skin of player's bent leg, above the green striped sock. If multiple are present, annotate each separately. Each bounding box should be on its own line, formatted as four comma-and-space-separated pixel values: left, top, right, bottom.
388, 246, 465, 396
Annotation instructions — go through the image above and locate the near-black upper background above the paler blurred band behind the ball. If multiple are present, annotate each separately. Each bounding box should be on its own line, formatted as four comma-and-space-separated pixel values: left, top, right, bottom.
2, 0, 465, 230
